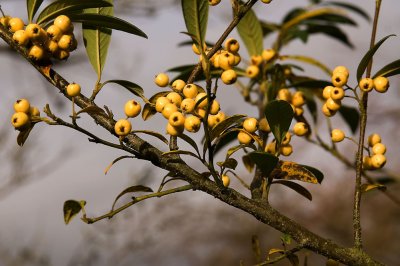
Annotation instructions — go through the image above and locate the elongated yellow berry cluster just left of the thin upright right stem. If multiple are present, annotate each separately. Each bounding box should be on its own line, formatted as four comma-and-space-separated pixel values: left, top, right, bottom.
322, 66, 349, 117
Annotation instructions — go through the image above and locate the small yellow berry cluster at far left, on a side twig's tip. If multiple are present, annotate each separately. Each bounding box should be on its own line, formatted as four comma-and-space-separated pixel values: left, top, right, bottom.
11, 99, 40, 131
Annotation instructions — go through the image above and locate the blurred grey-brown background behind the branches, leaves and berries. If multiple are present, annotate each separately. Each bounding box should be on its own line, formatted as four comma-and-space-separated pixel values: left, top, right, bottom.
0, 0, 400, 266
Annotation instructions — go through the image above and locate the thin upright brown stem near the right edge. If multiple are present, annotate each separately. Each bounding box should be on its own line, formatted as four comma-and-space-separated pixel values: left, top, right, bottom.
353, 0, 382, 250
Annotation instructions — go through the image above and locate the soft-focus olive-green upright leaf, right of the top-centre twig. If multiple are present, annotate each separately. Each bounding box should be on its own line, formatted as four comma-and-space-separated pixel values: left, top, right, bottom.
236, 9, 264, 56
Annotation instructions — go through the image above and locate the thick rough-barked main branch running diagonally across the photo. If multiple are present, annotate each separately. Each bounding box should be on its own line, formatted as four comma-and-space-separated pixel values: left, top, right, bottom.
0, 14, 382, 266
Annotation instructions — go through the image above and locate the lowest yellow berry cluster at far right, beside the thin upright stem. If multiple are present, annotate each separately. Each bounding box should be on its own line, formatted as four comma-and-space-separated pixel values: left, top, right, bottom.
363, 134, 386, 170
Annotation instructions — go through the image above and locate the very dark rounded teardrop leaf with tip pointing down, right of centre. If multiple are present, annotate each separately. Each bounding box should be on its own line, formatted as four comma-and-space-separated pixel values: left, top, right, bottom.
264, 100, 294, 145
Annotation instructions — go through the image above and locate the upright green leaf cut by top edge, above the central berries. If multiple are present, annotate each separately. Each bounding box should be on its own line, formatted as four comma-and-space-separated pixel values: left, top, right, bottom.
181, 0, 209, 46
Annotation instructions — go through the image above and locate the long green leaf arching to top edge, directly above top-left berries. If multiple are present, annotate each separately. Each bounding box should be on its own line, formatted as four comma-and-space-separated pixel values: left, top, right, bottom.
36, 0, 112, 24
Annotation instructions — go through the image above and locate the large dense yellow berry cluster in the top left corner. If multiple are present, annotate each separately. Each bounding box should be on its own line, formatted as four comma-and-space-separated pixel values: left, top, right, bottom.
0, 15, 77, 62
